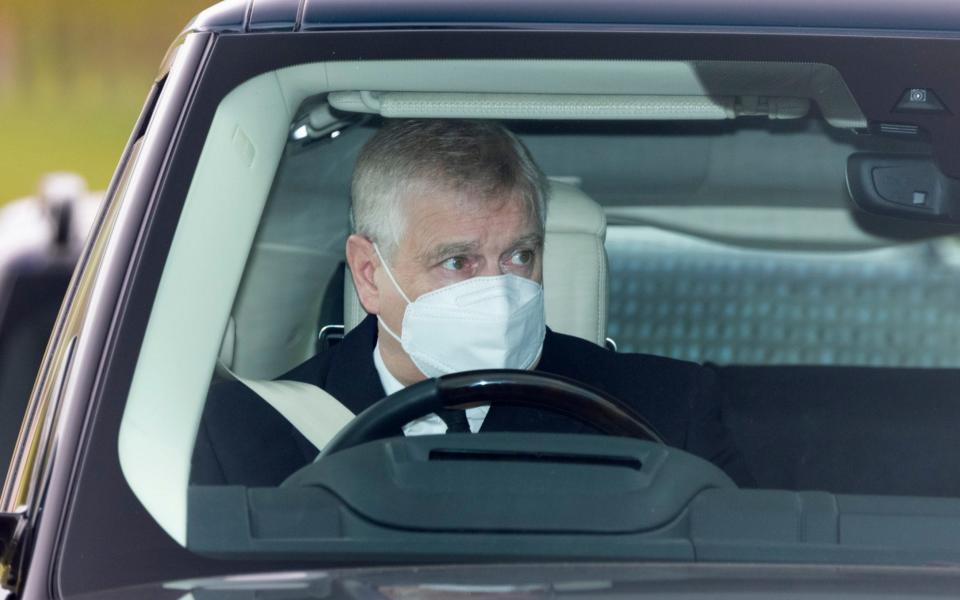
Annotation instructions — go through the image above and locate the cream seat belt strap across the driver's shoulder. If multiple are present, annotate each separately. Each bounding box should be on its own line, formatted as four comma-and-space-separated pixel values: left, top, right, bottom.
220, 364, 355, 450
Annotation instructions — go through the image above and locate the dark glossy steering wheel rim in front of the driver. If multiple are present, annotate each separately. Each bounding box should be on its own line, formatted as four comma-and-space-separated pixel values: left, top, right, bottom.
323, 369, 663, 456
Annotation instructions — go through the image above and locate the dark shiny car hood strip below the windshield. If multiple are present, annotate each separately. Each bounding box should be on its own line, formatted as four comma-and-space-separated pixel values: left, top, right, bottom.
69, 564, 960, 600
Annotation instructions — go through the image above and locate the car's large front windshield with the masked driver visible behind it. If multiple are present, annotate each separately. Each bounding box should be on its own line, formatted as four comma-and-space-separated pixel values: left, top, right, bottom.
118, 60, 960, 563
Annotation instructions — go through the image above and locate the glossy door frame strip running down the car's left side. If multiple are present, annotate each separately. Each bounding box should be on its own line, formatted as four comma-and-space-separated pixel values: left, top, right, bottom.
0, 33, 214, 597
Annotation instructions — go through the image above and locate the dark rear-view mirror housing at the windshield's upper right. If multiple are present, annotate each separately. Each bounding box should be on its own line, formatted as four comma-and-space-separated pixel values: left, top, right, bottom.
847, 153, 960, 224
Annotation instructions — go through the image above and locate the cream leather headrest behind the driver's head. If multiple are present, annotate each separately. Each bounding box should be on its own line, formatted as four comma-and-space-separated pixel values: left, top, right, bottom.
343, 181, 607, 346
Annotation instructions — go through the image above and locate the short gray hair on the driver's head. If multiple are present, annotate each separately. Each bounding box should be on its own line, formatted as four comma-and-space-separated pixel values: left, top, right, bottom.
350, 119, 548, 257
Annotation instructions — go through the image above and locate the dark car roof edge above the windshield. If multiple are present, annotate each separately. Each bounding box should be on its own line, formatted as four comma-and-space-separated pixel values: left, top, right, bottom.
187, 0, 960, 33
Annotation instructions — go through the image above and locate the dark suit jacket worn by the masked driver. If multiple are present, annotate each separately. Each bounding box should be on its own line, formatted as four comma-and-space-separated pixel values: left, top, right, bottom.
191, 317, 752, 486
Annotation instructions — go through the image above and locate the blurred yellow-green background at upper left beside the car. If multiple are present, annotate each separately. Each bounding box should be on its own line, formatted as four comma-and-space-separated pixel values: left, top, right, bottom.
0, 0, 213, 204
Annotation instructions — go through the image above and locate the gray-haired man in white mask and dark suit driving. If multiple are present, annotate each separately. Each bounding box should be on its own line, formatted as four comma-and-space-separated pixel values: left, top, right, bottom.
192, 120, 751, 485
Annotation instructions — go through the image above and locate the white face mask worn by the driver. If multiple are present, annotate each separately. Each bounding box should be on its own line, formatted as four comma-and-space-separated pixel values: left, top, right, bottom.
374, 244, 546, 377
